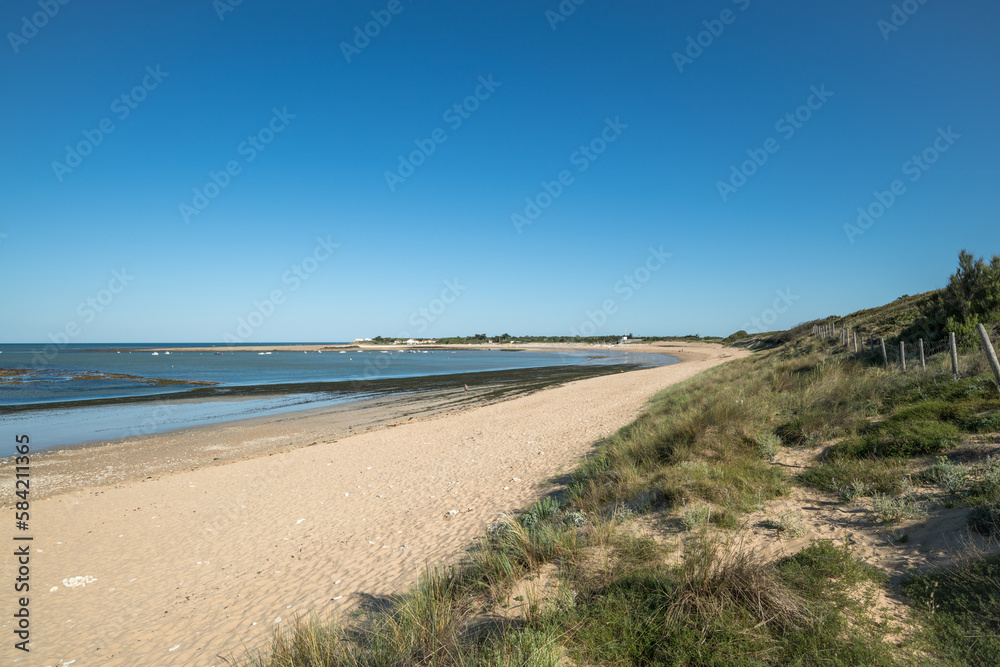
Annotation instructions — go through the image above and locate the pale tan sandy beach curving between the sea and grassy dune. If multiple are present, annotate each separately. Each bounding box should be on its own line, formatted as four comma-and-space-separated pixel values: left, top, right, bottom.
3, 343, 748, 665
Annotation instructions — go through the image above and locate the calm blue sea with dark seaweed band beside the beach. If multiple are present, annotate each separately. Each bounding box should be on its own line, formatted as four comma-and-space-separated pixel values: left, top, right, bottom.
0, 343, 676, 456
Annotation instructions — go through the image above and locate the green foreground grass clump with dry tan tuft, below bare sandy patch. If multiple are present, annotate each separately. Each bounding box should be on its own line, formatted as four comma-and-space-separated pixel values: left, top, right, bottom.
543, 534, 891, 665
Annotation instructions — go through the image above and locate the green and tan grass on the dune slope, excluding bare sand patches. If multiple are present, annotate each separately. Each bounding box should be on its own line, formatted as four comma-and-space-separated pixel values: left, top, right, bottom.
245, 330, 1000, 667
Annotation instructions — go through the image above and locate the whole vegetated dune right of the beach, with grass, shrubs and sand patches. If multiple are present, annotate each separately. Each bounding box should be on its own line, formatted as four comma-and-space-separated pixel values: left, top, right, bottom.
240, 252, 1000, 667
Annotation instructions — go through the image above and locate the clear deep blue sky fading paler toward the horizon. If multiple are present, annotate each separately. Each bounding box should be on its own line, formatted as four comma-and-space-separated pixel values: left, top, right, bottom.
0, 0, 1000, 343
